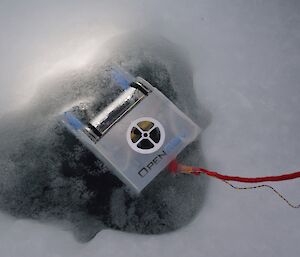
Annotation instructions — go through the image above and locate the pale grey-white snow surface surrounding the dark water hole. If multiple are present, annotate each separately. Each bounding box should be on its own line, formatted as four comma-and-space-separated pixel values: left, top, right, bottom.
0, 0, 300, 257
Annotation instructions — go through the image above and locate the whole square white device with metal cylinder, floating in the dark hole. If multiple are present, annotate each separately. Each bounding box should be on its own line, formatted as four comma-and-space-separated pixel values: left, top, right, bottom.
62, 69, 200, 193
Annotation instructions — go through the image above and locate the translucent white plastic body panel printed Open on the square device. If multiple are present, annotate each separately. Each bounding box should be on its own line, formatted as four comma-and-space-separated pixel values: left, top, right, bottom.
63, 77, 200, 193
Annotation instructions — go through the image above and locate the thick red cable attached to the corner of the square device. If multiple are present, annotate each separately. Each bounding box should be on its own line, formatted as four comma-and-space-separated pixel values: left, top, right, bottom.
169, 160, 300, 183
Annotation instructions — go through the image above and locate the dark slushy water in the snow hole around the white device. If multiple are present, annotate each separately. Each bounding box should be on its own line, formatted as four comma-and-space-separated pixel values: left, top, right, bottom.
0, 34, 209, 241
